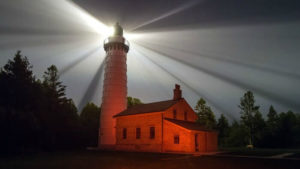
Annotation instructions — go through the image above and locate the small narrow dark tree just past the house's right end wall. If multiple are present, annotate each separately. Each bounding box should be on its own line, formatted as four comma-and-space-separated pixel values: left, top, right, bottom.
217, 114, 230, 146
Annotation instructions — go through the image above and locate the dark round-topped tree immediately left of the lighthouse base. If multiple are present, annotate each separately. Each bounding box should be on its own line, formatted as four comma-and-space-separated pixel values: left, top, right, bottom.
80, 103, 101, 146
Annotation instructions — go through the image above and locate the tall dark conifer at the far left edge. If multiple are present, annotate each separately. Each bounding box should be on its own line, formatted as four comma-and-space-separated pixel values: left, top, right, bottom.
0, 51, 39, 152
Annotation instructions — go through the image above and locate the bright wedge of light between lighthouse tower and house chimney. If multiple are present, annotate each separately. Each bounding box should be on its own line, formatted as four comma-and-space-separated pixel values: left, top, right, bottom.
127, 48, 175, 103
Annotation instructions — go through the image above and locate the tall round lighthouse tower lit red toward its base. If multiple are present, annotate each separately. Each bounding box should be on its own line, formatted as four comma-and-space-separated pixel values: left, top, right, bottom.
98, 23, 129, 148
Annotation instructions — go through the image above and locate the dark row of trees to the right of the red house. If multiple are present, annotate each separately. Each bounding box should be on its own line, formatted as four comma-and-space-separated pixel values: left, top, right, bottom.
195, 91, 300, 148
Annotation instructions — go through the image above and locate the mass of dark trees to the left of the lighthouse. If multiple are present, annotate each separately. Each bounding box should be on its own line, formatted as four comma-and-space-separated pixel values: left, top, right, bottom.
0, 51, 100, 154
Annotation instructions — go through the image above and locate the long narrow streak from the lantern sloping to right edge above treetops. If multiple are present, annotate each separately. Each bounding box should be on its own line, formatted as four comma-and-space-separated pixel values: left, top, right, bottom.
138, 44, 300, 112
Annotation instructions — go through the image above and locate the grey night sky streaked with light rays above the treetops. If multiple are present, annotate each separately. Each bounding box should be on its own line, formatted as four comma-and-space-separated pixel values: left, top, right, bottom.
0, 0, 300, 119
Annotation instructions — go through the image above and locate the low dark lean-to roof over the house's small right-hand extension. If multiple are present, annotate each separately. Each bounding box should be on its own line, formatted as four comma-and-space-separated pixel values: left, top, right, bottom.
164, 118, 215, 131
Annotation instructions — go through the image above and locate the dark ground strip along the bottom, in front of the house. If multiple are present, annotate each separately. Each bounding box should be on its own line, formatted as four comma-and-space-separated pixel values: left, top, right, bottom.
0, 151, 300, 169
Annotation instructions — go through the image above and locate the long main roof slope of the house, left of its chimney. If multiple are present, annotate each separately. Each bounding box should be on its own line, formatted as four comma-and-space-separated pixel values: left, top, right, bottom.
114, 100, 180, 117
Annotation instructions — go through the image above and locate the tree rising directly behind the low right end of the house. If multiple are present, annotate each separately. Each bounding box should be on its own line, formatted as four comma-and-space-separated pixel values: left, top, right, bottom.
195, 98, 216, 129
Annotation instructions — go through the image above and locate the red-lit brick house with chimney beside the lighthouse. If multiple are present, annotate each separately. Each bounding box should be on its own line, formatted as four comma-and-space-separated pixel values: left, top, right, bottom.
114, 85, 218, 153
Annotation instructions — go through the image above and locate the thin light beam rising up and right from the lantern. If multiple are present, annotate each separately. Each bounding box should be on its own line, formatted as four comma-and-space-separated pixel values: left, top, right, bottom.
130, 0, 202, 32
